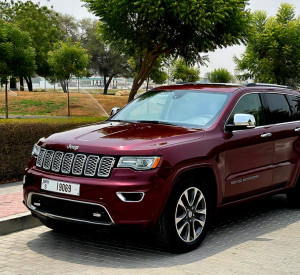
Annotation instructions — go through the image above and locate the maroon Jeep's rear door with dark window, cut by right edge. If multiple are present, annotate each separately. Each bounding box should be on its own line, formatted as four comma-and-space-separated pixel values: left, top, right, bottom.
263, 93, 300, 186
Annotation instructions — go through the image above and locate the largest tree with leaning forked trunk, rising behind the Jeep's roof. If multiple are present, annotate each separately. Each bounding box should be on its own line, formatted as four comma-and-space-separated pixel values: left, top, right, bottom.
84, 0, 249, 101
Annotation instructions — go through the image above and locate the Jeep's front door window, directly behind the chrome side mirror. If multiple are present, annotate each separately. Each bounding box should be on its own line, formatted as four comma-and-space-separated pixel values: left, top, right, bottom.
228, 94, 264, 126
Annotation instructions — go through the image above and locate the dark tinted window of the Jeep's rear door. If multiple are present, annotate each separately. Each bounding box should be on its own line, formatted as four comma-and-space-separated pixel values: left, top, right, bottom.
265, 93, 292, 124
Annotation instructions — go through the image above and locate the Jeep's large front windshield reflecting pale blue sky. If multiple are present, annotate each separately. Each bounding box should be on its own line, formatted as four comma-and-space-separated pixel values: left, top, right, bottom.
110, 90, 230, 128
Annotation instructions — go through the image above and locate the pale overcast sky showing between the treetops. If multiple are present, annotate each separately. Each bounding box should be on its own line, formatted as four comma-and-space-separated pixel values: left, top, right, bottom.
27, 0, 300, 76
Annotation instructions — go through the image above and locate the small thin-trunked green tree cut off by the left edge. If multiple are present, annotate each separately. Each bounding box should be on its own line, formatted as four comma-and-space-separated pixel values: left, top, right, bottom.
0, 20, 36, 118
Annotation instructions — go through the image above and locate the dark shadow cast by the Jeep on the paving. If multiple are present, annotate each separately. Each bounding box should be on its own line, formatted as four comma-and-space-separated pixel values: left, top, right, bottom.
27, 195, 300, 269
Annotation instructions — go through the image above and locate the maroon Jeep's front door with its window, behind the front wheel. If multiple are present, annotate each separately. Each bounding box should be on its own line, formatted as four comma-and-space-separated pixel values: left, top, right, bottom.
224, 93, 274, 202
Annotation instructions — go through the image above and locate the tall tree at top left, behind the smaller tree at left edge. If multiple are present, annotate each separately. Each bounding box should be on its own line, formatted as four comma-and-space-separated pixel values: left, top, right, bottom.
0, 0, 63, 91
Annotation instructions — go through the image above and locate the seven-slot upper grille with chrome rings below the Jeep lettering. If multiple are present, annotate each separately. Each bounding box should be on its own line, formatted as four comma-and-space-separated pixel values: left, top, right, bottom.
36, 148, 115, 178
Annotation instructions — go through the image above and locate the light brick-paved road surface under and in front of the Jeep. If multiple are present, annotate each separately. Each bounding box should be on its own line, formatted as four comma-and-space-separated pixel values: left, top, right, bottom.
0, 195, 300, 275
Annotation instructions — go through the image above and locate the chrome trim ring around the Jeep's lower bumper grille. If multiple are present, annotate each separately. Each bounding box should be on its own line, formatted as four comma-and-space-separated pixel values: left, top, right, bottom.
27, 192, 115, 225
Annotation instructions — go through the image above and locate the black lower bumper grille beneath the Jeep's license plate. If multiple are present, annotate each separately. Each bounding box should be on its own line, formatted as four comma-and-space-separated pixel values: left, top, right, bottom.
27, 193, 113, 225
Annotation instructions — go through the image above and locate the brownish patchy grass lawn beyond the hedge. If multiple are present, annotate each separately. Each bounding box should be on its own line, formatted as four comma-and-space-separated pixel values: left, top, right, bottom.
0, 89, 128, 117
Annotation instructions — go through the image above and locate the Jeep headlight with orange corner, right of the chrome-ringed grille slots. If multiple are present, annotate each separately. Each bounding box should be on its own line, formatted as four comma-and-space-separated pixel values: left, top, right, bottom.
117, 157, 160, 170
